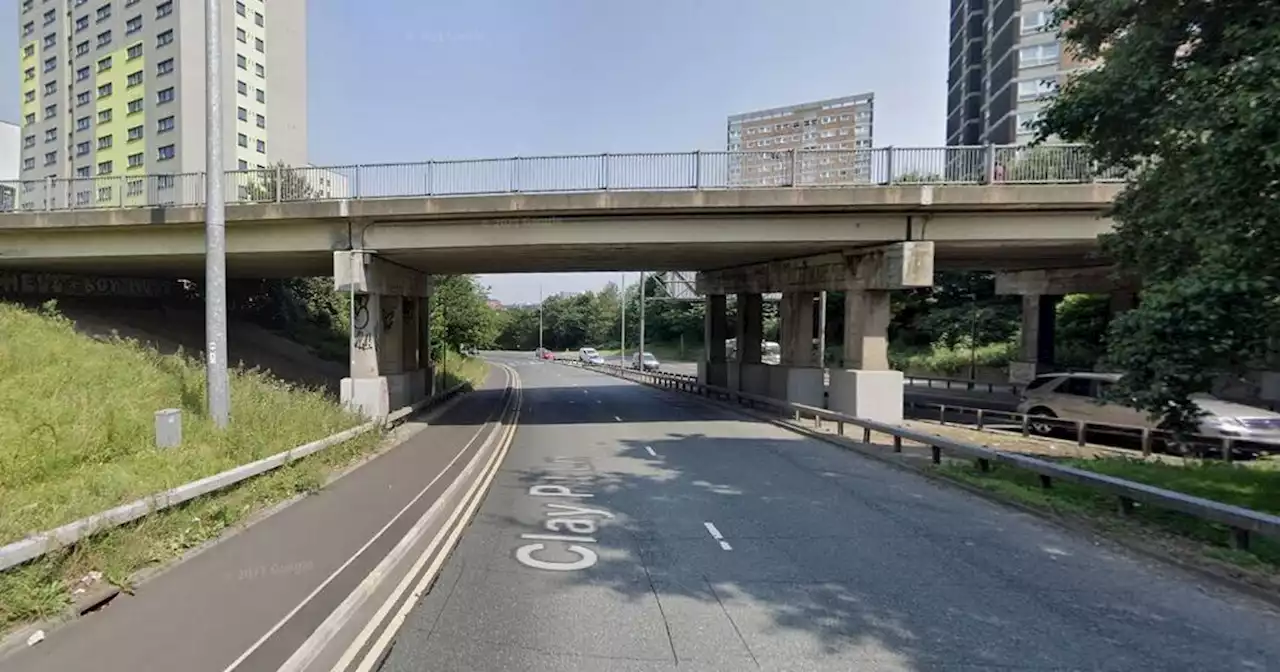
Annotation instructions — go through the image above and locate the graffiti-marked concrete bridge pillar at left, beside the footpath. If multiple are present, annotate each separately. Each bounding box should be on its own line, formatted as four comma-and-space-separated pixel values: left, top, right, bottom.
334, 251, 430, 419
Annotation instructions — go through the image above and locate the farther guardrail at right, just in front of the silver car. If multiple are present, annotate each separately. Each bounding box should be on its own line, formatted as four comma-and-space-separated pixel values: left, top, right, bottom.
904, 399, 1280, 462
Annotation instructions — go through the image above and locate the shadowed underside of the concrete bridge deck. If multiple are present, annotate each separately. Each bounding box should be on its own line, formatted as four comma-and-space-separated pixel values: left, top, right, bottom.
0, 241, 1098, 278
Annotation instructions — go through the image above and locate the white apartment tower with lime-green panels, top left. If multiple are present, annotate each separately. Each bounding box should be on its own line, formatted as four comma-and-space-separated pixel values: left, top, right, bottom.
18, 0, 307, 207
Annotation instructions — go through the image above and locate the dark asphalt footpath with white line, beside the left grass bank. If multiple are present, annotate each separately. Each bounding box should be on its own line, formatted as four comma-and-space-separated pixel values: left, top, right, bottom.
0, 367, 506, 672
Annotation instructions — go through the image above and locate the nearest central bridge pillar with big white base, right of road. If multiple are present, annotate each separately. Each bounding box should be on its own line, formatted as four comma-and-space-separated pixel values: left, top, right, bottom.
829, 289, 902, 424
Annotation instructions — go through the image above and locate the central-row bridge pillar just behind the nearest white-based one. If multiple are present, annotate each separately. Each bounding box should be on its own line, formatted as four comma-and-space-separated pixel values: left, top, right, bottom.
769, 292, 826, 408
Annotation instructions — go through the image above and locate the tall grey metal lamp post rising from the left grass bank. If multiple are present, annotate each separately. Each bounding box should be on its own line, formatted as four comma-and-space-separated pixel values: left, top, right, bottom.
205, 0, 232, 429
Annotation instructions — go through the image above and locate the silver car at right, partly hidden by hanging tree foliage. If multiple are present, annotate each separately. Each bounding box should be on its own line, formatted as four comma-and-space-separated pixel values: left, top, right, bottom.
1018, 372, 1280, 449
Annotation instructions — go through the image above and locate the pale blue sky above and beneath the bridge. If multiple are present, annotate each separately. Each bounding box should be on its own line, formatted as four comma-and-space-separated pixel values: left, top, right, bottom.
0, 0, 948, 302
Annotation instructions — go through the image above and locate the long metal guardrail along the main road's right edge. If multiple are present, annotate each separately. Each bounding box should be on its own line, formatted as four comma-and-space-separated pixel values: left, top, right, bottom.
571, 362, 1280, 549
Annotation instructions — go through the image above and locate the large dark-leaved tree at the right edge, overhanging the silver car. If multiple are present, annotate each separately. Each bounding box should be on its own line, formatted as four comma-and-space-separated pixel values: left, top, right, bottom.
1038, 0, 1280, 429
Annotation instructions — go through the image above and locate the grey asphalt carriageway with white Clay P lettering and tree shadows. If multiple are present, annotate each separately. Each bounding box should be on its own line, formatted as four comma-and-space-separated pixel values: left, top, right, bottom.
381, 355, 1280, 672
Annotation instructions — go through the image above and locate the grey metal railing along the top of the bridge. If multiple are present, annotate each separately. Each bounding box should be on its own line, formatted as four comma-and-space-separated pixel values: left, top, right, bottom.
0, 145, 1123, 211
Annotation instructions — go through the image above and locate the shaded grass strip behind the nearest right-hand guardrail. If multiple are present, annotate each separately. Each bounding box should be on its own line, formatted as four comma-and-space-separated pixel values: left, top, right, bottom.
940, 457, 1280, 573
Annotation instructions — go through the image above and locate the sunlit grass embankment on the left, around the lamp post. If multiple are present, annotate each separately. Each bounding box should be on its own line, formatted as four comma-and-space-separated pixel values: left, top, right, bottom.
0, 303, 484, 631
